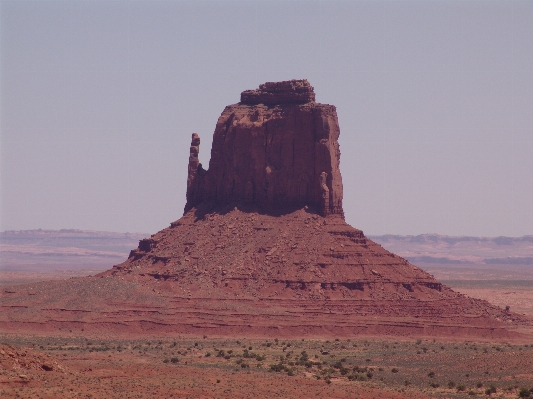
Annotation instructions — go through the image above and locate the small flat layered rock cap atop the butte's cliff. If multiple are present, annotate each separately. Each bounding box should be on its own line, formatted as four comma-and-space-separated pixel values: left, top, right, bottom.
241, 79, 315, 105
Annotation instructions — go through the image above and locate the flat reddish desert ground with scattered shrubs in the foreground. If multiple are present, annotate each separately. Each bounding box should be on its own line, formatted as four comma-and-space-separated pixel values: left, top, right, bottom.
0, 335, 533, 399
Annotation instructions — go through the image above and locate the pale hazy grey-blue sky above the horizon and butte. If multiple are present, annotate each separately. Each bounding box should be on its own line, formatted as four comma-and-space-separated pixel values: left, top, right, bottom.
0, 0, 533, 236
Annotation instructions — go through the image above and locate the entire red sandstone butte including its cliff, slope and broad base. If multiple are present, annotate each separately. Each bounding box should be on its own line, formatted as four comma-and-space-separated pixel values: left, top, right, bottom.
0, 80, 533, 339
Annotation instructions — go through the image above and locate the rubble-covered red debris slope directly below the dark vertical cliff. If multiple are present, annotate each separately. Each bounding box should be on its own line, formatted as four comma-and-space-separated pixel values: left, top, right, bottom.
108, 209, 459, 300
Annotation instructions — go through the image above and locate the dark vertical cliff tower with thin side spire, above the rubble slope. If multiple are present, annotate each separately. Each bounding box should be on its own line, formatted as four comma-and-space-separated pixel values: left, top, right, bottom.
185, 80, 343, 215
